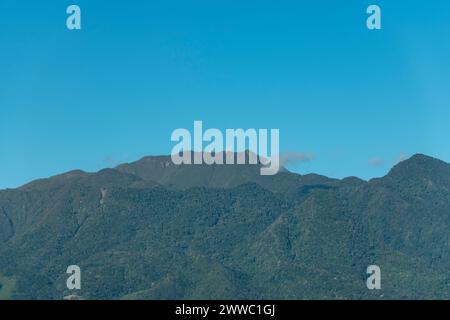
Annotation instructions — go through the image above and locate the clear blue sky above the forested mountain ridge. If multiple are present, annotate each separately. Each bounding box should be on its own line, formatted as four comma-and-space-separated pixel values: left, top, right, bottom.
0, 0, 450, 188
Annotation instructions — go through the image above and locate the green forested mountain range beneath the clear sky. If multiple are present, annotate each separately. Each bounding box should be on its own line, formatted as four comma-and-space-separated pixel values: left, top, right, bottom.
0, 154, 450, 299
